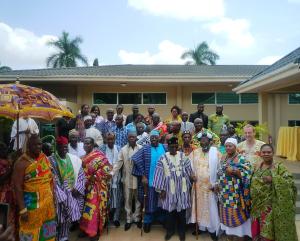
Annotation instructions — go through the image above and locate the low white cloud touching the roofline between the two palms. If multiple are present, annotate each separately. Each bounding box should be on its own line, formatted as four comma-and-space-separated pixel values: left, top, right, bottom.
119, 40, 186, 64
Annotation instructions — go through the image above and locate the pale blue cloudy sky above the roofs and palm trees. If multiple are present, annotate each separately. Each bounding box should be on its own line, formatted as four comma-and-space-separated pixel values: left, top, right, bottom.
0, 0, 300, 69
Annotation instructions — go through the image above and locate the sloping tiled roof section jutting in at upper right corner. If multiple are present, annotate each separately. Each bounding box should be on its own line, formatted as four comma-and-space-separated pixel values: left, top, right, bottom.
240, 47, 300, 85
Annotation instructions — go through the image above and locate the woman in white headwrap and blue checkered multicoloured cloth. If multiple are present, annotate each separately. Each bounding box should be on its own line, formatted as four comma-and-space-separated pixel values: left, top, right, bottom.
217, 138, 251, 241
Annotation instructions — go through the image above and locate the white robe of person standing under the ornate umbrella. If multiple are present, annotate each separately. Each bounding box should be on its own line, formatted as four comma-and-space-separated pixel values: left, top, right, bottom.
10, 118, 39, 151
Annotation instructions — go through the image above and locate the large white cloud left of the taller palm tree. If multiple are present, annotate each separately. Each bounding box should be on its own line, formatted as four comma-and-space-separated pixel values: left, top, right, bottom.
0, 22, 57, 69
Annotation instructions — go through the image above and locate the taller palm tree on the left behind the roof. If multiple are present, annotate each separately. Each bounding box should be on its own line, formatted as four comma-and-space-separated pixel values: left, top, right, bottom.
47, 31, 88, 68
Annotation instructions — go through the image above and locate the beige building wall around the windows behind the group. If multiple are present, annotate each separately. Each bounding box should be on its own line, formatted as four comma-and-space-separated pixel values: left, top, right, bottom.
77, 84, 258, 121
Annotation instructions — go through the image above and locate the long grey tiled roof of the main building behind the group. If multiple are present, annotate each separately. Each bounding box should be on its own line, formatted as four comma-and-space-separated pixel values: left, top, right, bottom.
0, 65, 267, 78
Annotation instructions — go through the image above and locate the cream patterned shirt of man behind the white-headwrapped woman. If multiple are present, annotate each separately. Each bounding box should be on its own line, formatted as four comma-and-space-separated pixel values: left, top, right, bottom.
237, 140, 265, 167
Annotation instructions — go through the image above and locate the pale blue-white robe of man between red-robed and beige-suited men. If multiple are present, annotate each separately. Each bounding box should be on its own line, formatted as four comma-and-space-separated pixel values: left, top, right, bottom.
100, 144, 124, 209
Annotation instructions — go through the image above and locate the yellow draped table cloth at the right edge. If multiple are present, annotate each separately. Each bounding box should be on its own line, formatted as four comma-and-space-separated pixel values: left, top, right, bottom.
276, 127, 300, 161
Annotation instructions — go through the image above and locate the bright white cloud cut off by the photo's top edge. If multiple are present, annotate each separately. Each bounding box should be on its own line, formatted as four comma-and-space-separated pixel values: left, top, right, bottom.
128, 0, 225, 21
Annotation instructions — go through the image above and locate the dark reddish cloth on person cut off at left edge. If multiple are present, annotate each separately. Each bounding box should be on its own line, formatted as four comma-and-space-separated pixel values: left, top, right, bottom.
0, 158, 17, 237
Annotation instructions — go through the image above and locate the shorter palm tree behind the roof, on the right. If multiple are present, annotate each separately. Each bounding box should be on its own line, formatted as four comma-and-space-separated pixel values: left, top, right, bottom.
181, 41, 220, 65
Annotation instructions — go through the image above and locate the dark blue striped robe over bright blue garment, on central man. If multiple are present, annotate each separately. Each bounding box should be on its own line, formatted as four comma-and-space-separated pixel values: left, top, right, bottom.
132, 144, 165, 213
